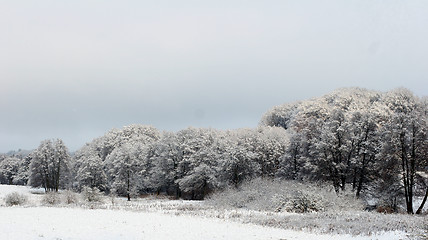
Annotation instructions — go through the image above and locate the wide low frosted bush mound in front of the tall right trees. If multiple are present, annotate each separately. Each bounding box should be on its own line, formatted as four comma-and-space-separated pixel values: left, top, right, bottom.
207, 179, 364, 213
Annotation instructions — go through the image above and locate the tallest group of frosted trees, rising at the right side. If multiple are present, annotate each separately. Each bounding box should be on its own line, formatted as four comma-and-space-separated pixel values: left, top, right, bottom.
262, 88, 428, 213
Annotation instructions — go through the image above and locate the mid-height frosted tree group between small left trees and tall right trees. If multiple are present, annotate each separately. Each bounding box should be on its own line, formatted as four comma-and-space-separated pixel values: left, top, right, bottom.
73, 125, 288, 199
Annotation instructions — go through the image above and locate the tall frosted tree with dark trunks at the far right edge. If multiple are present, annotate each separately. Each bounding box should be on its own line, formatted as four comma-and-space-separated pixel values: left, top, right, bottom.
381, 89, 428, 213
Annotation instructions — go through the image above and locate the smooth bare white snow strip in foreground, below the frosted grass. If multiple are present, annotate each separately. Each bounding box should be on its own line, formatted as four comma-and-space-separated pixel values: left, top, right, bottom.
0, 207, 403, 240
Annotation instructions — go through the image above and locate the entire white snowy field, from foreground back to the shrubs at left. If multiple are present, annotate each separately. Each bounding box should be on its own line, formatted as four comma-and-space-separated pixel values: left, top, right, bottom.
0, 185, 422, 240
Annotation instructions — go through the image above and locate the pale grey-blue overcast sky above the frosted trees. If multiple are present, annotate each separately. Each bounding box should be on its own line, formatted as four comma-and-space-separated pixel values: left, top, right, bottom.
0, 0, 428, 152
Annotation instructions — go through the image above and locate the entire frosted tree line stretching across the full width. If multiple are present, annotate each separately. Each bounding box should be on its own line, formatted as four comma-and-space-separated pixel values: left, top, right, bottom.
0, 88, 428, 213
